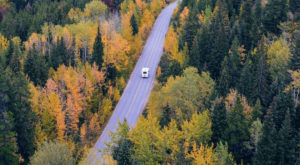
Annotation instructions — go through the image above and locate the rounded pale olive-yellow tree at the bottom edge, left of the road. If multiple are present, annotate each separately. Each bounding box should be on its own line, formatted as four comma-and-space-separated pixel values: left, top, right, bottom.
30, 141, 75, 165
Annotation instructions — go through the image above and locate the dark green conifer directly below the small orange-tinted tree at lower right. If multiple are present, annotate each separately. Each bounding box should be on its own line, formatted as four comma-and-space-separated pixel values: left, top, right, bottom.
225, 97, 250, 163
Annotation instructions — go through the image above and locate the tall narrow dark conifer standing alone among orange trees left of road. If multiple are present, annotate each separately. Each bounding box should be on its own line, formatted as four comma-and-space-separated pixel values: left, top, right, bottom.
92, 27, 104, 69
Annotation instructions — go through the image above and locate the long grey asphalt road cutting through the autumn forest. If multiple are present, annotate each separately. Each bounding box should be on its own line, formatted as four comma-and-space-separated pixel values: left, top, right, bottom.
88, 2, 177, 163
